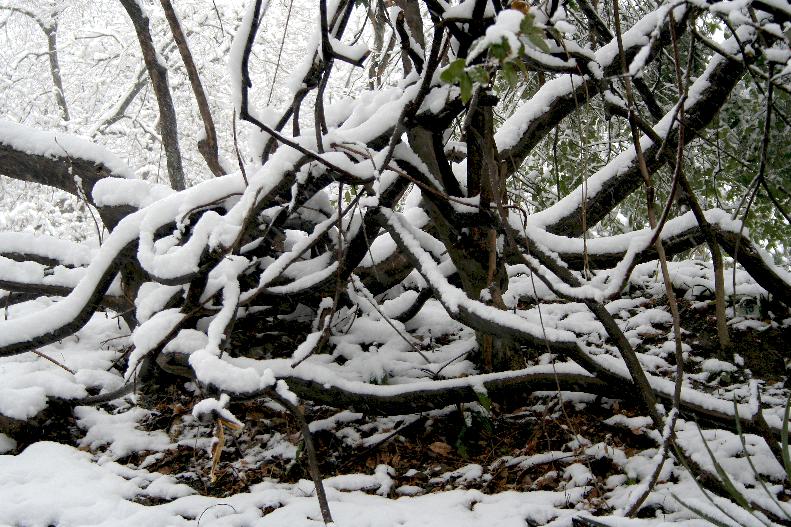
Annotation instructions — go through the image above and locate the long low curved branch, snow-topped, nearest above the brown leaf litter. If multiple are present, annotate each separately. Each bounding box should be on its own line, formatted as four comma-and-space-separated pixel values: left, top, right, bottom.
156, 352, 780, 439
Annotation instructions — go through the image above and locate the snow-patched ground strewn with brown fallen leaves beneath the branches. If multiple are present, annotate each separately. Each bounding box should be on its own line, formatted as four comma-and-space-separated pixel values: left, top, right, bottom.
0, 270, 791, 527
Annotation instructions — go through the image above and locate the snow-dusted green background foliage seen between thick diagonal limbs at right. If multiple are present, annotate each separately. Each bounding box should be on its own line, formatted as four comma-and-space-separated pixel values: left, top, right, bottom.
497, 17, 791, 254
